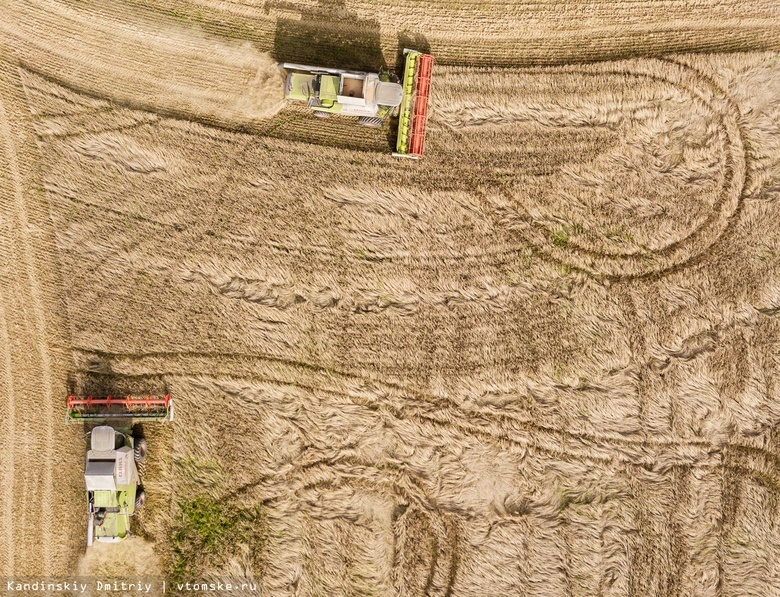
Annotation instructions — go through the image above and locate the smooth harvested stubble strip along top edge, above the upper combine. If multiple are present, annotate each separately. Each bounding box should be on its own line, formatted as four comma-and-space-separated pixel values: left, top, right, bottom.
123, 0, 780, 64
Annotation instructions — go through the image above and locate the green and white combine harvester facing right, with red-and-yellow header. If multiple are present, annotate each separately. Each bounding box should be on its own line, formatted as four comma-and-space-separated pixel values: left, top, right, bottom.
279, 49, 433, 159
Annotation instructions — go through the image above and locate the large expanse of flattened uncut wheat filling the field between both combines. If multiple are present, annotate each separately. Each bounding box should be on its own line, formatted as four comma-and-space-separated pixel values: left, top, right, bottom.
0, 3, 780, 595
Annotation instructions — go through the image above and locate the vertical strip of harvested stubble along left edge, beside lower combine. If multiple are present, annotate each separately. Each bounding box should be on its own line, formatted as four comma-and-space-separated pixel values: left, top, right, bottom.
0, 60, 79, 575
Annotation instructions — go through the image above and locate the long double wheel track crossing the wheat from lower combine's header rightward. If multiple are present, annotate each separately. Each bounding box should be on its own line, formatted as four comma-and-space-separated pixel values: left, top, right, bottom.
76, 348, 780, 490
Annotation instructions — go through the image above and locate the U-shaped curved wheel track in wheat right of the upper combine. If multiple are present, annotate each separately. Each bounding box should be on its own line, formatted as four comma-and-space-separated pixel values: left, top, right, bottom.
439, 59, 749, 279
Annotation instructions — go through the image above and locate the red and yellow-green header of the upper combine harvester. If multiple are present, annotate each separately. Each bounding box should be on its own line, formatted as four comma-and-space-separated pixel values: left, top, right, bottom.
393, 49, 433, 159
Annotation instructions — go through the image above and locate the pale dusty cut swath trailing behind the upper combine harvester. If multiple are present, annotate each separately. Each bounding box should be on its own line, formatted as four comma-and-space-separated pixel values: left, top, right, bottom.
0, 0, 284, 126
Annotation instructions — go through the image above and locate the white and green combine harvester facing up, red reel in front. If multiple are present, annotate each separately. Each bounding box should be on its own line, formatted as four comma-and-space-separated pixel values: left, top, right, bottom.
67, 394, 173, 547
